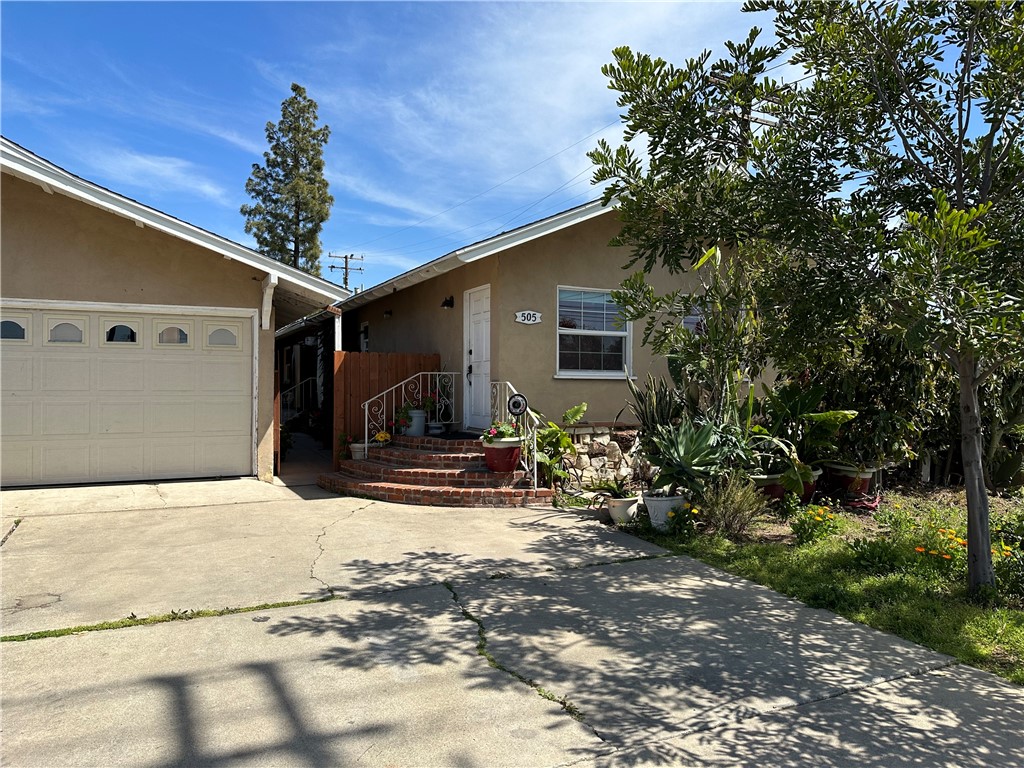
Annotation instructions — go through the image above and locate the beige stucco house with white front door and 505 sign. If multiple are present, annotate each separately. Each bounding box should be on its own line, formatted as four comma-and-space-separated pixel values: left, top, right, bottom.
341, 202, 689, 430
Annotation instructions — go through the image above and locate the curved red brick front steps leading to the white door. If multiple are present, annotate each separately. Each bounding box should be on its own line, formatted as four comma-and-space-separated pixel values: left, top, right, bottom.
317, 435, 552, 507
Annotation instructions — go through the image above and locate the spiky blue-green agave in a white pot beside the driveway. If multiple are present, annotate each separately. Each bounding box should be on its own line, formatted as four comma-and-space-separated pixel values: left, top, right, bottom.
643, 418, 723, 530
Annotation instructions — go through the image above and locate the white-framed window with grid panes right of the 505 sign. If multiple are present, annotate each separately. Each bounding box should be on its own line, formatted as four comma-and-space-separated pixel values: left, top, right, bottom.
558, 287, 630, 377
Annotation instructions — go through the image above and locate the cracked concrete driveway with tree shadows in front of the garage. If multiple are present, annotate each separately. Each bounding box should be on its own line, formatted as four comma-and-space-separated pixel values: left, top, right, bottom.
0, 480, 1024, 766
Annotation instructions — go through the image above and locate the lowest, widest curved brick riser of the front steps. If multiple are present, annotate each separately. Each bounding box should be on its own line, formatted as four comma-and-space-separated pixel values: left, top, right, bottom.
317, 474, 551, 507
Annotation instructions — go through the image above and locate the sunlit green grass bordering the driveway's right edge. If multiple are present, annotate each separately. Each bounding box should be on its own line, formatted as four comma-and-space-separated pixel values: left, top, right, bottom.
637, 495, 1024, 685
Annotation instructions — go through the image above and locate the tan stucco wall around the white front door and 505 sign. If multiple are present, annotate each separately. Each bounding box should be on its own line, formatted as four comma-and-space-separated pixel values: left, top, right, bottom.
345, 211, 690, 424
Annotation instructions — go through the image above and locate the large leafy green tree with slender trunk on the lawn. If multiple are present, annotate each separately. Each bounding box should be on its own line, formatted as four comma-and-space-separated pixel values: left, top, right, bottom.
591, 0, 1024, 589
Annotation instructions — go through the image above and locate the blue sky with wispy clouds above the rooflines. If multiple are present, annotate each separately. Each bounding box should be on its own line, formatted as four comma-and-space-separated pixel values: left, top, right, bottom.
0, 2, 770, 288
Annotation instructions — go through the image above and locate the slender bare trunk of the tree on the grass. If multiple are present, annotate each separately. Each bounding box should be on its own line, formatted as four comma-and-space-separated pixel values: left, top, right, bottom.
957, 355, 995, 592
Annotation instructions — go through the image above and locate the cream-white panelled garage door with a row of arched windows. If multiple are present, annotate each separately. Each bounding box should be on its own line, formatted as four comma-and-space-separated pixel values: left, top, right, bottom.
0, 307, 254, 485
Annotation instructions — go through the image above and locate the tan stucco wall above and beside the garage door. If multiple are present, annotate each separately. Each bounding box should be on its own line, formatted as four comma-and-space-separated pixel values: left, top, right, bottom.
0, 173, 273, 480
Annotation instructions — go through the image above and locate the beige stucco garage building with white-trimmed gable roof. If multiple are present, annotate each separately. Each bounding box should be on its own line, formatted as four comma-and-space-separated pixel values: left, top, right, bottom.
0, 138, 349, 486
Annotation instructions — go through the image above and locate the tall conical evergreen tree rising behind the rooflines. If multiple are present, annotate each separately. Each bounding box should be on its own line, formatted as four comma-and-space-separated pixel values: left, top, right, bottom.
242, 83, 334, 275
